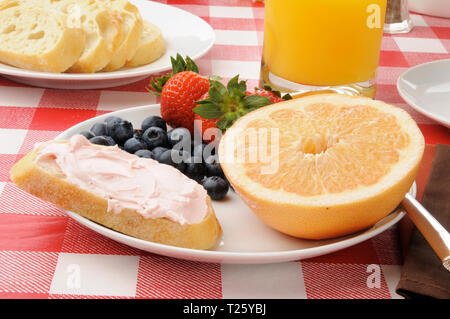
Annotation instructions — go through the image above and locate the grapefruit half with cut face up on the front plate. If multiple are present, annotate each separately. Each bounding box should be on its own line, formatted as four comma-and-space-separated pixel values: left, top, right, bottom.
219, 94, 424, 239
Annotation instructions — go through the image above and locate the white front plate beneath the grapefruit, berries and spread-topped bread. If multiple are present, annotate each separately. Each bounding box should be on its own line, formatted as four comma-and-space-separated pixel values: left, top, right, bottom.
56, 104, 416, 264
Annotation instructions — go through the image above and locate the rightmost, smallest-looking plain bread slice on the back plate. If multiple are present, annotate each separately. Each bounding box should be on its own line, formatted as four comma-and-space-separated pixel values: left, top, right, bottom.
126, 21, 166, 67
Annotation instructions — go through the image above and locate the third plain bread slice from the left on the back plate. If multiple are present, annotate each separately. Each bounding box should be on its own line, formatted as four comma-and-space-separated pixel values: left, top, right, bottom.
97, 0, 143, 71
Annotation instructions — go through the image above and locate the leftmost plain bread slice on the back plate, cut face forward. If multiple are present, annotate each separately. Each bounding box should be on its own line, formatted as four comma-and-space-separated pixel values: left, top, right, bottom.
0, 1, 86, 72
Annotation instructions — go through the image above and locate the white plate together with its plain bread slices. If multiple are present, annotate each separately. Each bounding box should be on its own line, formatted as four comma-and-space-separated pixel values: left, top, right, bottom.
0, 0, 215, 89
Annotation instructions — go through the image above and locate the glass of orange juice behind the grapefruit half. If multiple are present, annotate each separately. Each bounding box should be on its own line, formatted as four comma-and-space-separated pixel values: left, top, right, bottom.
261, 0, 387, 97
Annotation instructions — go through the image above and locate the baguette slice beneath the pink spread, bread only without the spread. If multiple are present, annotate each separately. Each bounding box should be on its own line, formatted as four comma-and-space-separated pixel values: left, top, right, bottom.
10, 144, 222, 249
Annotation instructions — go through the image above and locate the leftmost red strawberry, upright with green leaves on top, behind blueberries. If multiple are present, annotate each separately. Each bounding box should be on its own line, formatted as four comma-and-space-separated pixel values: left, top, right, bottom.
150, 54, 209, 133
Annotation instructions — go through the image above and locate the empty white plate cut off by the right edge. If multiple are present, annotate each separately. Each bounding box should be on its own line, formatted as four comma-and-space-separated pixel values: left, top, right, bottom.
397, 60, 450, 127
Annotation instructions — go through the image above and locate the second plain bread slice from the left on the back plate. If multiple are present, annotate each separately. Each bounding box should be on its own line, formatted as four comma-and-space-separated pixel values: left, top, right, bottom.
51, 0, 122, 73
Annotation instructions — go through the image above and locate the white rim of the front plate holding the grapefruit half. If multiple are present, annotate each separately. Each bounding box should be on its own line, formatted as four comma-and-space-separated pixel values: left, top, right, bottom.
55, 104, 417, 264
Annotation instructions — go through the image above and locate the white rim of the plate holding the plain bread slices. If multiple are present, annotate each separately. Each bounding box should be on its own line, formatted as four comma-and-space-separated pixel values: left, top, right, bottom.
0, 0, 216, 81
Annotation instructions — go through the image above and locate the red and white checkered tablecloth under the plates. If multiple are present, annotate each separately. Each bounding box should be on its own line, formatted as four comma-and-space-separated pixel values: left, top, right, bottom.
0, 0, 450, 298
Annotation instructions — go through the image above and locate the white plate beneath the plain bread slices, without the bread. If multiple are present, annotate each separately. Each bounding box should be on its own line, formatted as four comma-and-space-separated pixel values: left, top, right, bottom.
0, 0, 215, 89
